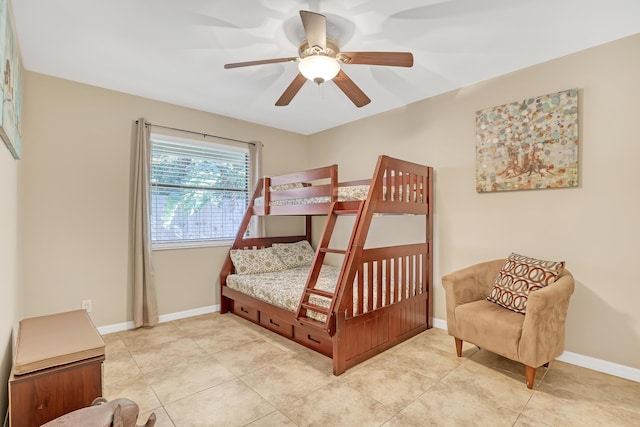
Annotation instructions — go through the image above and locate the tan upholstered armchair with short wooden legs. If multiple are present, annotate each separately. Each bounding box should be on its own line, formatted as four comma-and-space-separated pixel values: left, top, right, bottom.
442, 259, 575, 389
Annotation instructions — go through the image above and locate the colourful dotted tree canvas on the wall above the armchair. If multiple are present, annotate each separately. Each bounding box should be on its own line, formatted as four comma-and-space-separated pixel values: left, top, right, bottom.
476, 89, 579, 193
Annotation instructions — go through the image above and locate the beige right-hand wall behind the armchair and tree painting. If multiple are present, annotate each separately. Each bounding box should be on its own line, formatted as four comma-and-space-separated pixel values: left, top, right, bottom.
310, 35, 640, 368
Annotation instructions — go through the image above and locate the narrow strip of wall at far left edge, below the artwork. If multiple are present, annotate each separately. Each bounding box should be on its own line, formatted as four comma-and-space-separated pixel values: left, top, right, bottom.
0, 141, 22, 423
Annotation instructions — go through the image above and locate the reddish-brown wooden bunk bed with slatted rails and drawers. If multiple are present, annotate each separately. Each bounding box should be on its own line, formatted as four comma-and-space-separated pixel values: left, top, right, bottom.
220, 155, 434, 375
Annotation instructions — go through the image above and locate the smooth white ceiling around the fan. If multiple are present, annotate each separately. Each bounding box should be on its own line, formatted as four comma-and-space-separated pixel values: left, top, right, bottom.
12, 0, 640, 135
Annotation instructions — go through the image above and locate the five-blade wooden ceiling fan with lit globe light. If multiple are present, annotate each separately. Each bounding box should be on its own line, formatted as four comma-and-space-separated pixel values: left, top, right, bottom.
224, 10, 413, 107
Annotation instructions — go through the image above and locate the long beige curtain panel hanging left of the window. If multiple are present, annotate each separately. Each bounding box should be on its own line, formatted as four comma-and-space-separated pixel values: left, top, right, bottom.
132, 119, 158, 328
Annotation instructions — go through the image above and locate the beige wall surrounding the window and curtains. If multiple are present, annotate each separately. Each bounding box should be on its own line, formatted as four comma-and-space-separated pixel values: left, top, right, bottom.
21, 72, 307, 328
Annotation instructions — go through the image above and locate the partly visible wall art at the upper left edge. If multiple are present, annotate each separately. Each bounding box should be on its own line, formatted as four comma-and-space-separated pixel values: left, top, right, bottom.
0, 0, 22, 159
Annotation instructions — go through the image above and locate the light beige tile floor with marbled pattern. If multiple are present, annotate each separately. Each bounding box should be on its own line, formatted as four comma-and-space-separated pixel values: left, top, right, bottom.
104, 313, 640, 427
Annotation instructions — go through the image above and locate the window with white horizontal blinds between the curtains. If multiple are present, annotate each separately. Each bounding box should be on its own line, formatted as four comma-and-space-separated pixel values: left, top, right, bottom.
150, 135, 251, 249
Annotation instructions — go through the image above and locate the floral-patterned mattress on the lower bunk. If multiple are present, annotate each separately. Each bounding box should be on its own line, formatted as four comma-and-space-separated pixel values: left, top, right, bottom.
227, 265, 340, 322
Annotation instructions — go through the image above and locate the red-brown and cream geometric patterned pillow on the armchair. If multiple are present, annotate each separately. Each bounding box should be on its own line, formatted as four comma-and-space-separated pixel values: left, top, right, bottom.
487, 253, 564, 314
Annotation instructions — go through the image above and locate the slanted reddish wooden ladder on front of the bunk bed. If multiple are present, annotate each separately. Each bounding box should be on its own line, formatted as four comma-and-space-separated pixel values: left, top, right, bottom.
296, 201, 364, 335
